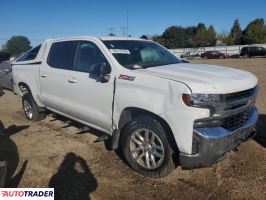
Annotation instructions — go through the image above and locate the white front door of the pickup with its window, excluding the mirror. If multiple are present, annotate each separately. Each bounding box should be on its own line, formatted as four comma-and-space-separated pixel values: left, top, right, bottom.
66, 41, 115, 131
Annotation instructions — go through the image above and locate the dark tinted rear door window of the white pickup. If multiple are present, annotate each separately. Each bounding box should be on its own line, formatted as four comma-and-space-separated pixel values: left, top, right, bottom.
47, 41, 77, 70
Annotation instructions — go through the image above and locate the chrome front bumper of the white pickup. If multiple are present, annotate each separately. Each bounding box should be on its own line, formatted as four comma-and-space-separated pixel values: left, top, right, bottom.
179, 108, 258, 169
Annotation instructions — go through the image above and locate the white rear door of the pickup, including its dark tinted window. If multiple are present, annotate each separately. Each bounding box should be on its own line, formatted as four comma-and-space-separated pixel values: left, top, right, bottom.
40, 41, 78, 114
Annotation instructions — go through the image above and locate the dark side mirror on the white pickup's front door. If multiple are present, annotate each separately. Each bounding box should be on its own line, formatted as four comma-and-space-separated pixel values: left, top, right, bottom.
90, 63, 111, 83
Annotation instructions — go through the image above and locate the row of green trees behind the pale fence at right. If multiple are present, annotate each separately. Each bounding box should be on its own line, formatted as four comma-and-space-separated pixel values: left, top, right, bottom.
152, 18, 266, 49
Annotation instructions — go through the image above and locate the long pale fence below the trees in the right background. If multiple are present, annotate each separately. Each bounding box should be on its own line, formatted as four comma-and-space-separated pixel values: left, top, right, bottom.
170, 44, 266, 56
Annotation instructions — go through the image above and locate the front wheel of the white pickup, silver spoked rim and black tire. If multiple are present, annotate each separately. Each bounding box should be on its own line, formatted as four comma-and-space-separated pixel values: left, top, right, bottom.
121, 115, 175, 178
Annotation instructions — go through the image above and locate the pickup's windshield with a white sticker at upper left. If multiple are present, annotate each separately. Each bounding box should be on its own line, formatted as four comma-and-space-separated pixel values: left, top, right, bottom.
103, 40, 181, 69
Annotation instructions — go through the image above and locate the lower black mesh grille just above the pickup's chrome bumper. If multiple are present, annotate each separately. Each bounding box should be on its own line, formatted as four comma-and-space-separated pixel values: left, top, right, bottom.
222, 110, 251, 131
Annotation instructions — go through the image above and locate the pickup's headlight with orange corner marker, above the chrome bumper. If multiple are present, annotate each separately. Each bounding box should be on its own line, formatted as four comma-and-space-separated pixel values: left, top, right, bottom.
182, 94, 222, 107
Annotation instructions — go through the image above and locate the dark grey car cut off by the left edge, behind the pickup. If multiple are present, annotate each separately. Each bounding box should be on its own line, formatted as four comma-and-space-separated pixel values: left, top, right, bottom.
0, 61, 13, 90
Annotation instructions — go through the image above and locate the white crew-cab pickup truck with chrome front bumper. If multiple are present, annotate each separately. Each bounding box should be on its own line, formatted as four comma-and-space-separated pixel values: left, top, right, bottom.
13, 37, 258, 178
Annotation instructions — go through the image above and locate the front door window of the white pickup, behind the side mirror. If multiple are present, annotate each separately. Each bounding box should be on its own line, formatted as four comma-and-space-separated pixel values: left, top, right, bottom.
73, 41, 111, 73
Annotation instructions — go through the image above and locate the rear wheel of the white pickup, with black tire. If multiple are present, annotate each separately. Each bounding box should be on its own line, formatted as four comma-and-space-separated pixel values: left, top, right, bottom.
22, 93, 45, 122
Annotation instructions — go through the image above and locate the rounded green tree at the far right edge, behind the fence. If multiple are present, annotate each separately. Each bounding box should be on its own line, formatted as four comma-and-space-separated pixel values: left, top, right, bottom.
243, 18, 266, 44
